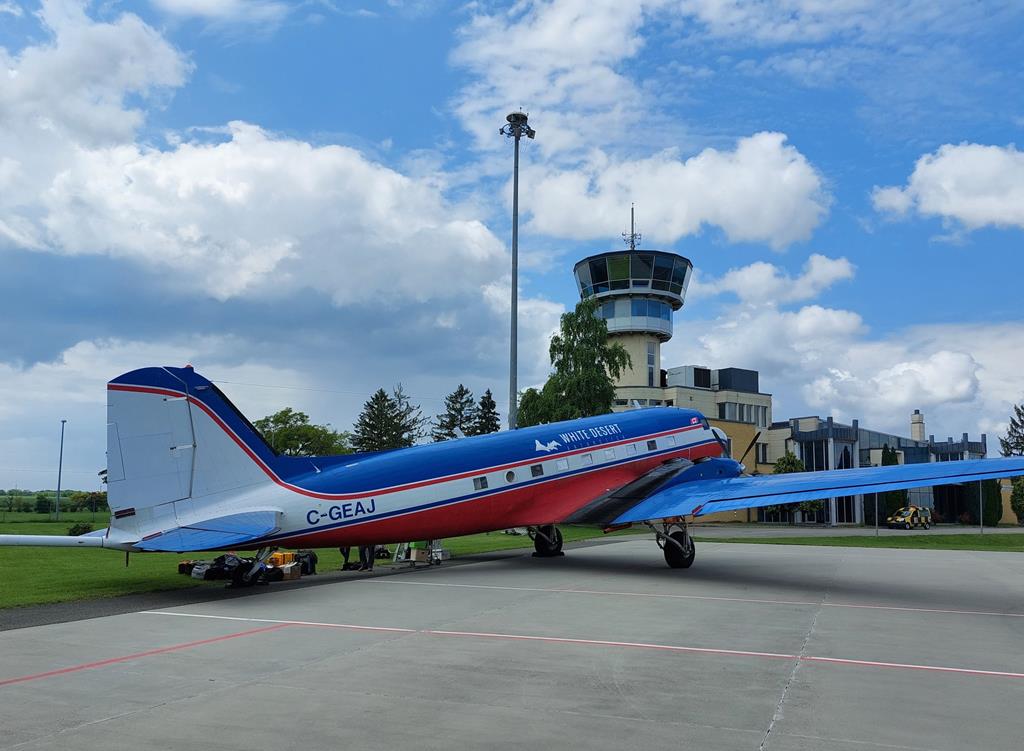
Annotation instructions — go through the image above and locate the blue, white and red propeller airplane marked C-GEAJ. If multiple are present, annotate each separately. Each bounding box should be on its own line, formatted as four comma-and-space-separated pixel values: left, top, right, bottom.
6, 366, 1024, 576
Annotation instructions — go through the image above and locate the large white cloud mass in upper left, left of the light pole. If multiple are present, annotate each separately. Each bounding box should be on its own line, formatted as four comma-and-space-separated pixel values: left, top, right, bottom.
0, 1, 505, 304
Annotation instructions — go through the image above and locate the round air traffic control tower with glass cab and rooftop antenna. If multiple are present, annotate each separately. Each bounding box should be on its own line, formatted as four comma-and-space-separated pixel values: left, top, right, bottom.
572, 217, 693, 388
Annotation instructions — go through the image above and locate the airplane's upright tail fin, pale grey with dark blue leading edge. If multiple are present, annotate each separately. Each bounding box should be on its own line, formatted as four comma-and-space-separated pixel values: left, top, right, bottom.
106, 366, 276, 530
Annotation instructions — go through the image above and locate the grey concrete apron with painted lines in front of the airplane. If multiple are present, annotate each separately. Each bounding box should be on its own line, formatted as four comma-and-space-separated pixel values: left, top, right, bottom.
0, 537, 1024, 751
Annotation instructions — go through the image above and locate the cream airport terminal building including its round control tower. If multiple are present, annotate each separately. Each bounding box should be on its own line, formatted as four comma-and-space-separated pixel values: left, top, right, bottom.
573, 247, 1014, 525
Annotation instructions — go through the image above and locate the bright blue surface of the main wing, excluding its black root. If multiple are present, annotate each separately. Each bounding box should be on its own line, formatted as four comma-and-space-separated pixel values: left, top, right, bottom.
613, 457, 1024, 524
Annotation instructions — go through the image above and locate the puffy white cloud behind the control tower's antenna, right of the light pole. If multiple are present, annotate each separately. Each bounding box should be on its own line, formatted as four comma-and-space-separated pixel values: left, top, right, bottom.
524, 132, 830, 249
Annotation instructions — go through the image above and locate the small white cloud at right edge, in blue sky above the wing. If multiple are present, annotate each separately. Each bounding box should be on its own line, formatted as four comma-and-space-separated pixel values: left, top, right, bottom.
871, 143, 1024, 230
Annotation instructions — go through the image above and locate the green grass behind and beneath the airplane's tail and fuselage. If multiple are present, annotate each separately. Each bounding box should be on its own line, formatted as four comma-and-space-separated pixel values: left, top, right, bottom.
0, 520, 632, 608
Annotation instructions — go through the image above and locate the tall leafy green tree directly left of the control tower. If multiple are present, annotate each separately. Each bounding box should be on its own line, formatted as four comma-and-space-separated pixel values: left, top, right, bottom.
518, 299, 631, 426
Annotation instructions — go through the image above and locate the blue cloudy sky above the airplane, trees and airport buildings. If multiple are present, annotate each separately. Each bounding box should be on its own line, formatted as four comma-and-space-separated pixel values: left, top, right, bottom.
0, 0, 1024, 489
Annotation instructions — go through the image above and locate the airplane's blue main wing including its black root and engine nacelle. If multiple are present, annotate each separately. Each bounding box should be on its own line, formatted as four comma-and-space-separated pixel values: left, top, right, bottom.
565, 457, 1024, 526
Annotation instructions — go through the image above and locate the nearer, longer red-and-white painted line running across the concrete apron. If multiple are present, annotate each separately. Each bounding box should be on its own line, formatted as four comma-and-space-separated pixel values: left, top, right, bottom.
142, 611, 1024, 685
